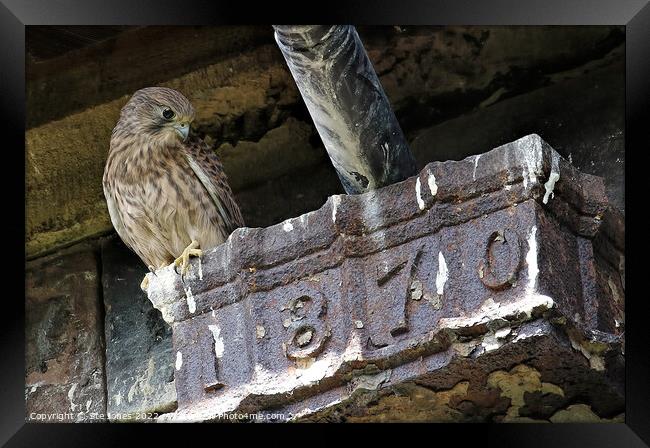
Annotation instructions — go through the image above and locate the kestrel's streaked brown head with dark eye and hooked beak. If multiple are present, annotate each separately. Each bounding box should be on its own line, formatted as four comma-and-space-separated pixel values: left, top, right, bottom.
118, 87, 194, 142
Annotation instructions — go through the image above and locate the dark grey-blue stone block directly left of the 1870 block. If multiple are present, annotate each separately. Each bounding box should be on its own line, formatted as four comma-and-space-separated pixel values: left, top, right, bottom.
102, 237, 176, 421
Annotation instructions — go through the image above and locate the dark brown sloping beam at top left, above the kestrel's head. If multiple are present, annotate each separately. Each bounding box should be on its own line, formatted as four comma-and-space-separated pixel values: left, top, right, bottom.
26, 26, 273, 129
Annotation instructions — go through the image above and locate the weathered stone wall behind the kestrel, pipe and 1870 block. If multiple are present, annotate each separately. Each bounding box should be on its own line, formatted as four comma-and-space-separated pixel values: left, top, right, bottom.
25, 26, 624, 420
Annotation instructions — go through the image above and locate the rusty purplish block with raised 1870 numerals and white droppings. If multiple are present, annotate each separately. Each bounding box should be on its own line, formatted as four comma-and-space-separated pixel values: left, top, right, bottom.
148, 134, 624, 421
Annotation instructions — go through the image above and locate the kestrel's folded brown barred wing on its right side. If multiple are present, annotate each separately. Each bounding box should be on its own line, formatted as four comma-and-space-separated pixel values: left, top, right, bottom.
183, 139, 245, 235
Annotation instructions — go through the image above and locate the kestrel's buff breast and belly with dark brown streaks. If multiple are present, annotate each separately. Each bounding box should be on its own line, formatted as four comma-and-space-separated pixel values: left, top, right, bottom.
107, 147, 227, 268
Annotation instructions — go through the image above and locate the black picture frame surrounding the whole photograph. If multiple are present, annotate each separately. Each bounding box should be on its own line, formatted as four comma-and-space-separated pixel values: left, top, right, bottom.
0, 0, 650, 447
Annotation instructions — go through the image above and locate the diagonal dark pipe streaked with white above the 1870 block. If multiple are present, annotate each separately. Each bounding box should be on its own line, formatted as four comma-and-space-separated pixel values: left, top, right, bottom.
274, 25, 416, 194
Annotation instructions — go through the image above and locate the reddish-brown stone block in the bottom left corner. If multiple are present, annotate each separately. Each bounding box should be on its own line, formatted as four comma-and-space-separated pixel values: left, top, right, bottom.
25, 244, 106, 422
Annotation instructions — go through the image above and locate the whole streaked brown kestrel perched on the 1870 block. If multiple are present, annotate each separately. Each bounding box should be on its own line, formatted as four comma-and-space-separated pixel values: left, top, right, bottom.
103, 87, 244, 289
